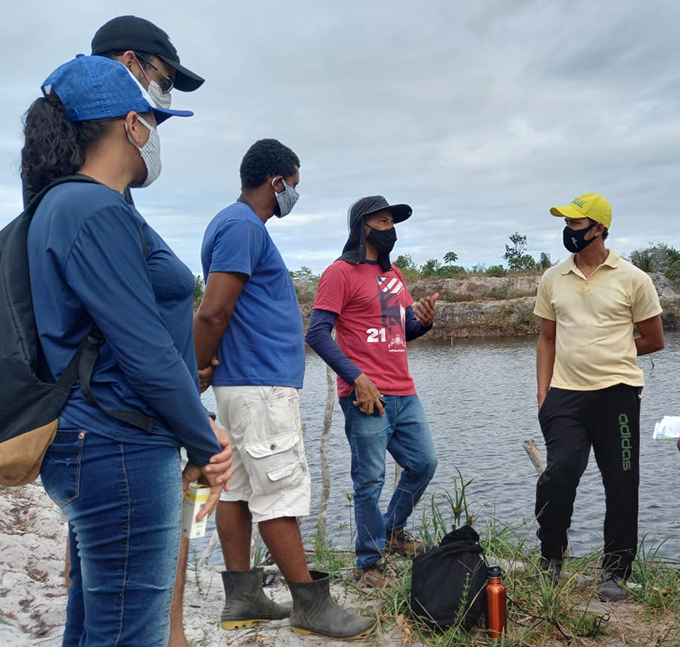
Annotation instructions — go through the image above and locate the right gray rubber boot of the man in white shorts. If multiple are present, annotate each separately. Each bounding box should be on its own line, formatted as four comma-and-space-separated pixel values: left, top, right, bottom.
288, 571, 375, 640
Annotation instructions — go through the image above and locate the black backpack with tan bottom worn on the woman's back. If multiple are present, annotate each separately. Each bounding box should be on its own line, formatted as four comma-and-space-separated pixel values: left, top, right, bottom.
0, 175, 153, 485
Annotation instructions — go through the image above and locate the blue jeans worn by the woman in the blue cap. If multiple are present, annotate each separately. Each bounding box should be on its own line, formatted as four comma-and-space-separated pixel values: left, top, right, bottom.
40, 421, 182, 647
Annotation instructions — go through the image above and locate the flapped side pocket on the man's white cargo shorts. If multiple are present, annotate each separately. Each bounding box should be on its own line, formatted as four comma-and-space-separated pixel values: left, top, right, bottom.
245, 432, 304, 494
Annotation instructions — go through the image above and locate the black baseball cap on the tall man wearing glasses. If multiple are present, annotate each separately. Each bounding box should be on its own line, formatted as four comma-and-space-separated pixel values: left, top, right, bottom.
92, 16, 205, 92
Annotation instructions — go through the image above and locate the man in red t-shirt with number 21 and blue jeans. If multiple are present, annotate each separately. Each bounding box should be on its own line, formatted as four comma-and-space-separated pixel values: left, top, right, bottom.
306, 196, 439, 587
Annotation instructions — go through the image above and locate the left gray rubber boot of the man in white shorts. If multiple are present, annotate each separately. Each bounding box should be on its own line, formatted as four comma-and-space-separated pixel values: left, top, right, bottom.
220, 568, 292, 629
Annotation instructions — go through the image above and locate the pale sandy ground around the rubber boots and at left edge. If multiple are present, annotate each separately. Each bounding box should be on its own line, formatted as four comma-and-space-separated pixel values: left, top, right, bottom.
0, 485, 401, 647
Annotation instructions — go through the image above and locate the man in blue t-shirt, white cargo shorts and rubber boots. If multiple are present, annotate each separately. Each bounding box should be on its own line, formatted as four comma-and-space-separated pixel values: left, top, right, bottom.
194, 139, 375, 639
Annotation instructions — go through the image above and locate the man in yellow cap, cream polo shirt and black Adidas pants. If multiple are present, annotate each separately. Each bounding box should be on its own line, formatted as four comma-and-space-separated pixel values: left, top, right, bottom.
534, 193, 664, 600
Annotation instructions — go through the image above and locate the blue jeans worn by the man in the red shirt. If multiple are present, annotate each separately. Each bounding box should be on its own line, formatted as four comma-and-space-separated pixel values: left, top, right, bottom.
340, 395, 437, 569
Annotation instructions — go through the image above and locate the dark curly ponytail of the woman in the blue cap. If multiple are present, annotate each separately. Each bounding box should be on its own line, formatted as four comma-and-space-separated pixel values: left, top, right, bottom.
21, 92, 119, 200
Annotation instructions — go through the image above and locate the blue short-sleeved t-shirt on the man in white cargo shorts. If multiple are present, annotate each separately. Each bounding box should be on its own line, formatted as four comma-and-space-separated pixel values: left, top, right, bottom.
201, 202, 305, 389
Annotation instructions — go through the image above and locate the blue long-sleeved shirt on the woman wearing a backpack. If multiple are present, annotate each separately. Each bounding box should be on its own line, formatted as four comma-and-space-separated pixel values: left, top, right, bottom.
28, 183, 221, 466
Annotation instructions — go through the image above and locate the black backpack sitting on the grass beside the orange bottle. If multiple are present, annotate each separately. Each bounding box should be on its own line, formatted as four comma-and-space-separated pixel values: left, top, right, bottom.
411, 526, 487, 629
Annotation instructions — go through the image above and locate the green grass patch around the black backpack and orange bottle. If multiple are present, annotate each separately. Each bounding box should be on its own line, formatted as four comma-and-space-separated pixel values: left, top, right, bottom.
317, 472, 680, 647
